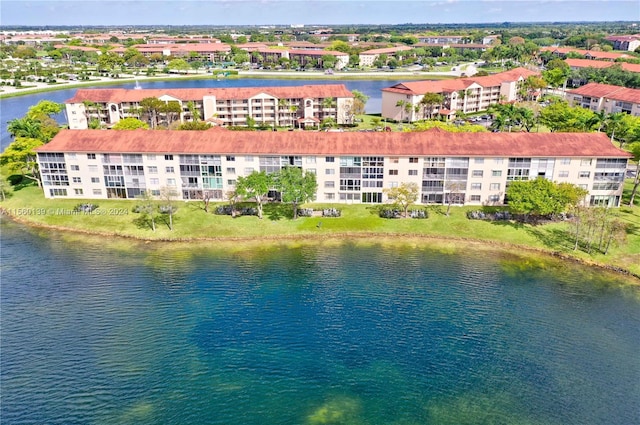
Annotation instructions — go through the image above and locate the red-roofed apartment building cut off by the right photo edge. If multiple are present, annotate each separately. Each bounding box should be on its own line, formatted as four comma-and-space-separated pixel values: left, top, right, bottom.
565, 83, 640, 116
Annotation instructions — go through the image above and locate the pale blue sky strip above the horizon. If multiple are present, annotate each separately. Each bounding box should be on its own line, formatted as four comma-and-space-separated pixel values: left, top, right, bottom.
0, 0, 640, 26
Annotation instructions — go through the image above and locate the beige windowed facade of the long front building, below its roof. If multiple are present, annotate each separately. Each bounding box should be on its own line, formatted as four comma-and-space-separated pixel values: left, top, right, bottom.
38, 152, 626, 206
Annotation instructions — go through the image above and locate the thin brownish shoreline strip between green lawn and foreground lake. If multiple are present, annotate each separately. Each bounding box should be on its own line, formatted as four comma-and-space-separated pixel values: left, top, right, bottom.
0, 207, 640, 285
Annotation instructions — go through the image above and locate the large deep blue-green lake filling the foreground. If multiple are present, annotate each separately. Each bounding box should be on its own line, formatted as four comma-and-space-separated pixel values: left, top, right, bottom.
0, 222, 640, 425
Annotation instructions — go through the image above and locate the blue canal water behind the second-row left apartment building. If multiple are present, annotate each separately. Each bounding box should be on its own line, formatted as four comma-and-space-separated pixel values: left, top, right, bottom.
0, 78, 400, 151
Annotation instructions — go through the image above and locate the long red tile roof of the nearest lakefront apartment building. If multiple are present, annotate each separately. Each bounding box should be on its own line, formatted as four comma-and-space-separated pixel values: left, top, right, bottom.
37, 128, 631, 158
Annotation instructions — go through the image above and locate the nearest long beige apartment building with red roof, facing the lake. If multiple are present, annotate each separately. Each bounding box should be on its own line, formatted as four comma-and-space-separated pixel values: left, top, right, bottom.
37, 128, 630, 206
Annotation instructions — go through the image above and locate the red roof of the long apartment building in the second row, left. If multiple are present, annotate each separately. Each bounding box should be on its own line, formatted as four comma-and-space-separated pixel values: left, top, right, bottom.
65, 84, 353, 103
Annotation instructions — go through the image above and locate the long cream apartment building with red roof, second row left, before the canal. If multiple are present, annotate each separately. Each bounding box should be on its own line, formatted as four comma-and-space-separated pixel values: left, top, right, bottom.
65, 84, 353, 130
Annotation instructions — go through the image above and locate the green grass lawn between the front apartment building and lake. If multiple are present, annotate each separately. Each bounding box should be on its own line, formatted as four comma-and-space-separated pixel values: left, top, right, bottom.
0, 186, 640, 276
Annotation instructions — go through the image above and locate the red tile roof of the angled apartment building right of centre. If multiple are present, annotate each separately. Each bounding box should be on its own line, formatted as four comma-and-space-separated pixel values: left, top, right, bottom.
382, 68, 539, 95
